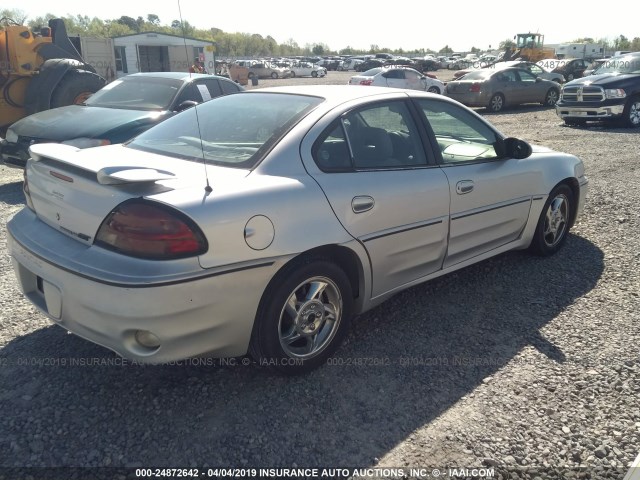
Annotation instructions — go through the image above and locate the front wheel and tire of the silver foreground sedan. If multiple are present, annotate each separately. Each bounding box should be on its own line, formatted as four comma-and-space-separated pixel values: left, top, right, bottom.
529, 184, 574, 257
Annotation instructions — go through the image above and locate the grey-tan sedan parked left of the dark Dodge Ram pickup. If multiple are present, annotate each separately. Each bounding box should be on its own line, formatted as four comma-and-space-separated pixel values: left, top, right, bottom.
445, 68, 560, 112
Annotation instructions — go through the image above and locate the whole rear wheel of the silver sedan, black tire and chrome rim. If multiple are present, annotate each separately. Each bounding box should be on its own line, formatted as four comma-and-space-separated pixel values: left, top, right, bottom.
250, 257, 353, 374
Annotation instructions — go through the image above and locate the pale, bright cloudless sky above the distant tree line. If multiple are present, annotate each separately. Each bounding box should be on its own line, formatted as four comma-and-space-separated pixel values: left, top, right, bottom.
6, 0, 640, 52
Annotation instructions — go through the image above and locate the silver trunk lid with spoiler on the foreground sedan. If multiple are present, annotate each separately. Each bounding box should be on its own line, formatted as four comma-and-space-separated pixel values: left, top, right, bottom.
25, 144, 247, 245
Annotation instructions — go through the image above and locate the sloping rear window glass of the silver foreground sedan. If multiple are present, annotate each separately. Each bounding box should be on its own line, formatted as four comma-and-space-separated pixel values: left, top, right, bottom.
127, 93, 322, 168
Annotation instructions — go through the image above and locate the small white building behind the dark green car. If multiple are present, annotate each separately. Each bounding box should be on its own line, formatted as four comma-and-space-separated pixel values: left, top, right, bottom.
113, 32, 215, 77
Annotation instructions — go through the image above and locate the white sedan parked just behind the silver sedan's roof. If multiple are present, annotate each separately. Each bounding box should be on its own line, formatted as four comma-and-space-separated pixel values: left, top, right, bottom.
349, 67, 444, 93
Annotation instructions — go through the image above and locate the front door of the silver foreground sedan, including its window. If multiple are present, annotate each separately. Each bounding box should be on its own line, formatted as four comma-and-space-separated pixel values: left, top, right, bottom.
417, 99, 541, 268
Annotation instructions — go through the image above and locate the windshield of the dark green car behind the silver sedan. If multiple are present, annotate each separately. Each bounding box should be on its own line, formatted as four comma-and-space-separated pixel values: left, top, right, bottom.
85, 76, 182, 110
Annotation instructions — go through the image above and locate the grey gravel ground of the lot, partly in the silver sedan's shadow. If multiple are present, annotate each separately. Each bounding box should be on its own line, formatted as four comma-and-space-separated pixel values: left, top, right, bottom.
0, 72, 640, 479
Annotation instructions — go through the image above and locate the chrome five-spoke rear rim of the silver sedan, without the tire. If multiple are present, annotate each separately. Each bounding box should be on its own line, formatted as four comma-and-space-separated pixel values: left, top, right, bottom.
278, 277, 342, 359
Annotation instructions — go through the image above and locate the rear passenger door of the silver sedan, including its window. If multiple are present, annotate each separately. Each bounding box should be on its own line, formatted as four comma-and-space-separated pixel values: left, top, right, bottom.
312, 100, 449, 297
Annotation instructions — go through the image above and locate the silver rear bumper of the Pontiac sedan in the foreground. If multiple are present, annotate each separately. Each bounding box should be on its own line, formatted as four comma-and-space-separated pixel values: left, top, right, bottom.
8, 209, 280, 364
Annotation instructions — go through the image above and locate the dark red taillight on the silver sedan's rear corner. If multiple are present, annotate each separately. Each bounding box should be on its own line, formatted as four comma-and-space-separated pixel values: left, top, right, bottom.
96, 200, 207, 260
